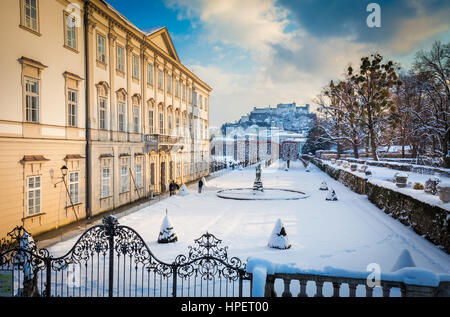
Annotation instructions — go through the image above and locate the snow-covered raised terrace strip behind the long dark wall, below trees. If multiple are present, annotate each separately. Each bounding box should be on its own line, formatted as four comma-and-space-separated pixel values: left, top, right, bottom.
323, 160, 450, 211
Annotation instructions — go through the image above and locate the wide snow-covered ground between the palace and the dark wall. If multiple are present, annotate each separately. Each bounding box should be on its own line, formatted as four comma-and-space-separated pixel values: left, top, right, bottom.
49, 163, 450, 273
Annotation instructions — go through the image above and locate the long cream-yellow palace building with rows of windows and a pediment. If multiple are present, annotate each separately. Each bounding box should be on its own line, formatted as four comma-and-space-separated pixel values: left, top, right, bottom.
0, 0, 212, 237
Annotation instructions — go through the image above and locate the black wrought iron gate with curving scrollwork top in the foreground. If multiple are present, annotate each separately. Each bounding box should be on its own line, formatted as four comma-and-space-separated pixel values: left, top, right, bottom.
0, 216, 251, 297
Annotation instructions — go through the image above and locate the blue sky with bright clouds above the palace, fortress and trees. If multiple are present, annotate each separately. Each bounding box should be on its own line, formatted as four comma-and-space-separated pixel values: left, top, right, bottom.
107, 0, 450, 126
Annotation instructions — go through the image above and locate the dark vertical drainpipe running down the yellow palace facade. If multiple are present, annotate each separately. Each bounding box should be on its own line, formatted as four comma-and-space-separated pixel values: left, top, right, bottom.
84, 0, 92, 219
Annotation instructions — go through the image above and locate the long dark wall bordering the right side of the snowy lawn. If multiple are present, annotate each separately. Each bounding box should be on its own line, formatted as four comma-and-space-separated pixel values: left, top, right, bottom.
304, 156, 450, 253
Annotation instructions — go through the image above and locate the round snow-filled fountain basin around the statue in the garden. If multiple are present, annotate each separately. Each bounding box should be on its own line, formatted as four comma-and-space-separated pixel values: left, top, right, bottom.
217, 188, 309, 200
